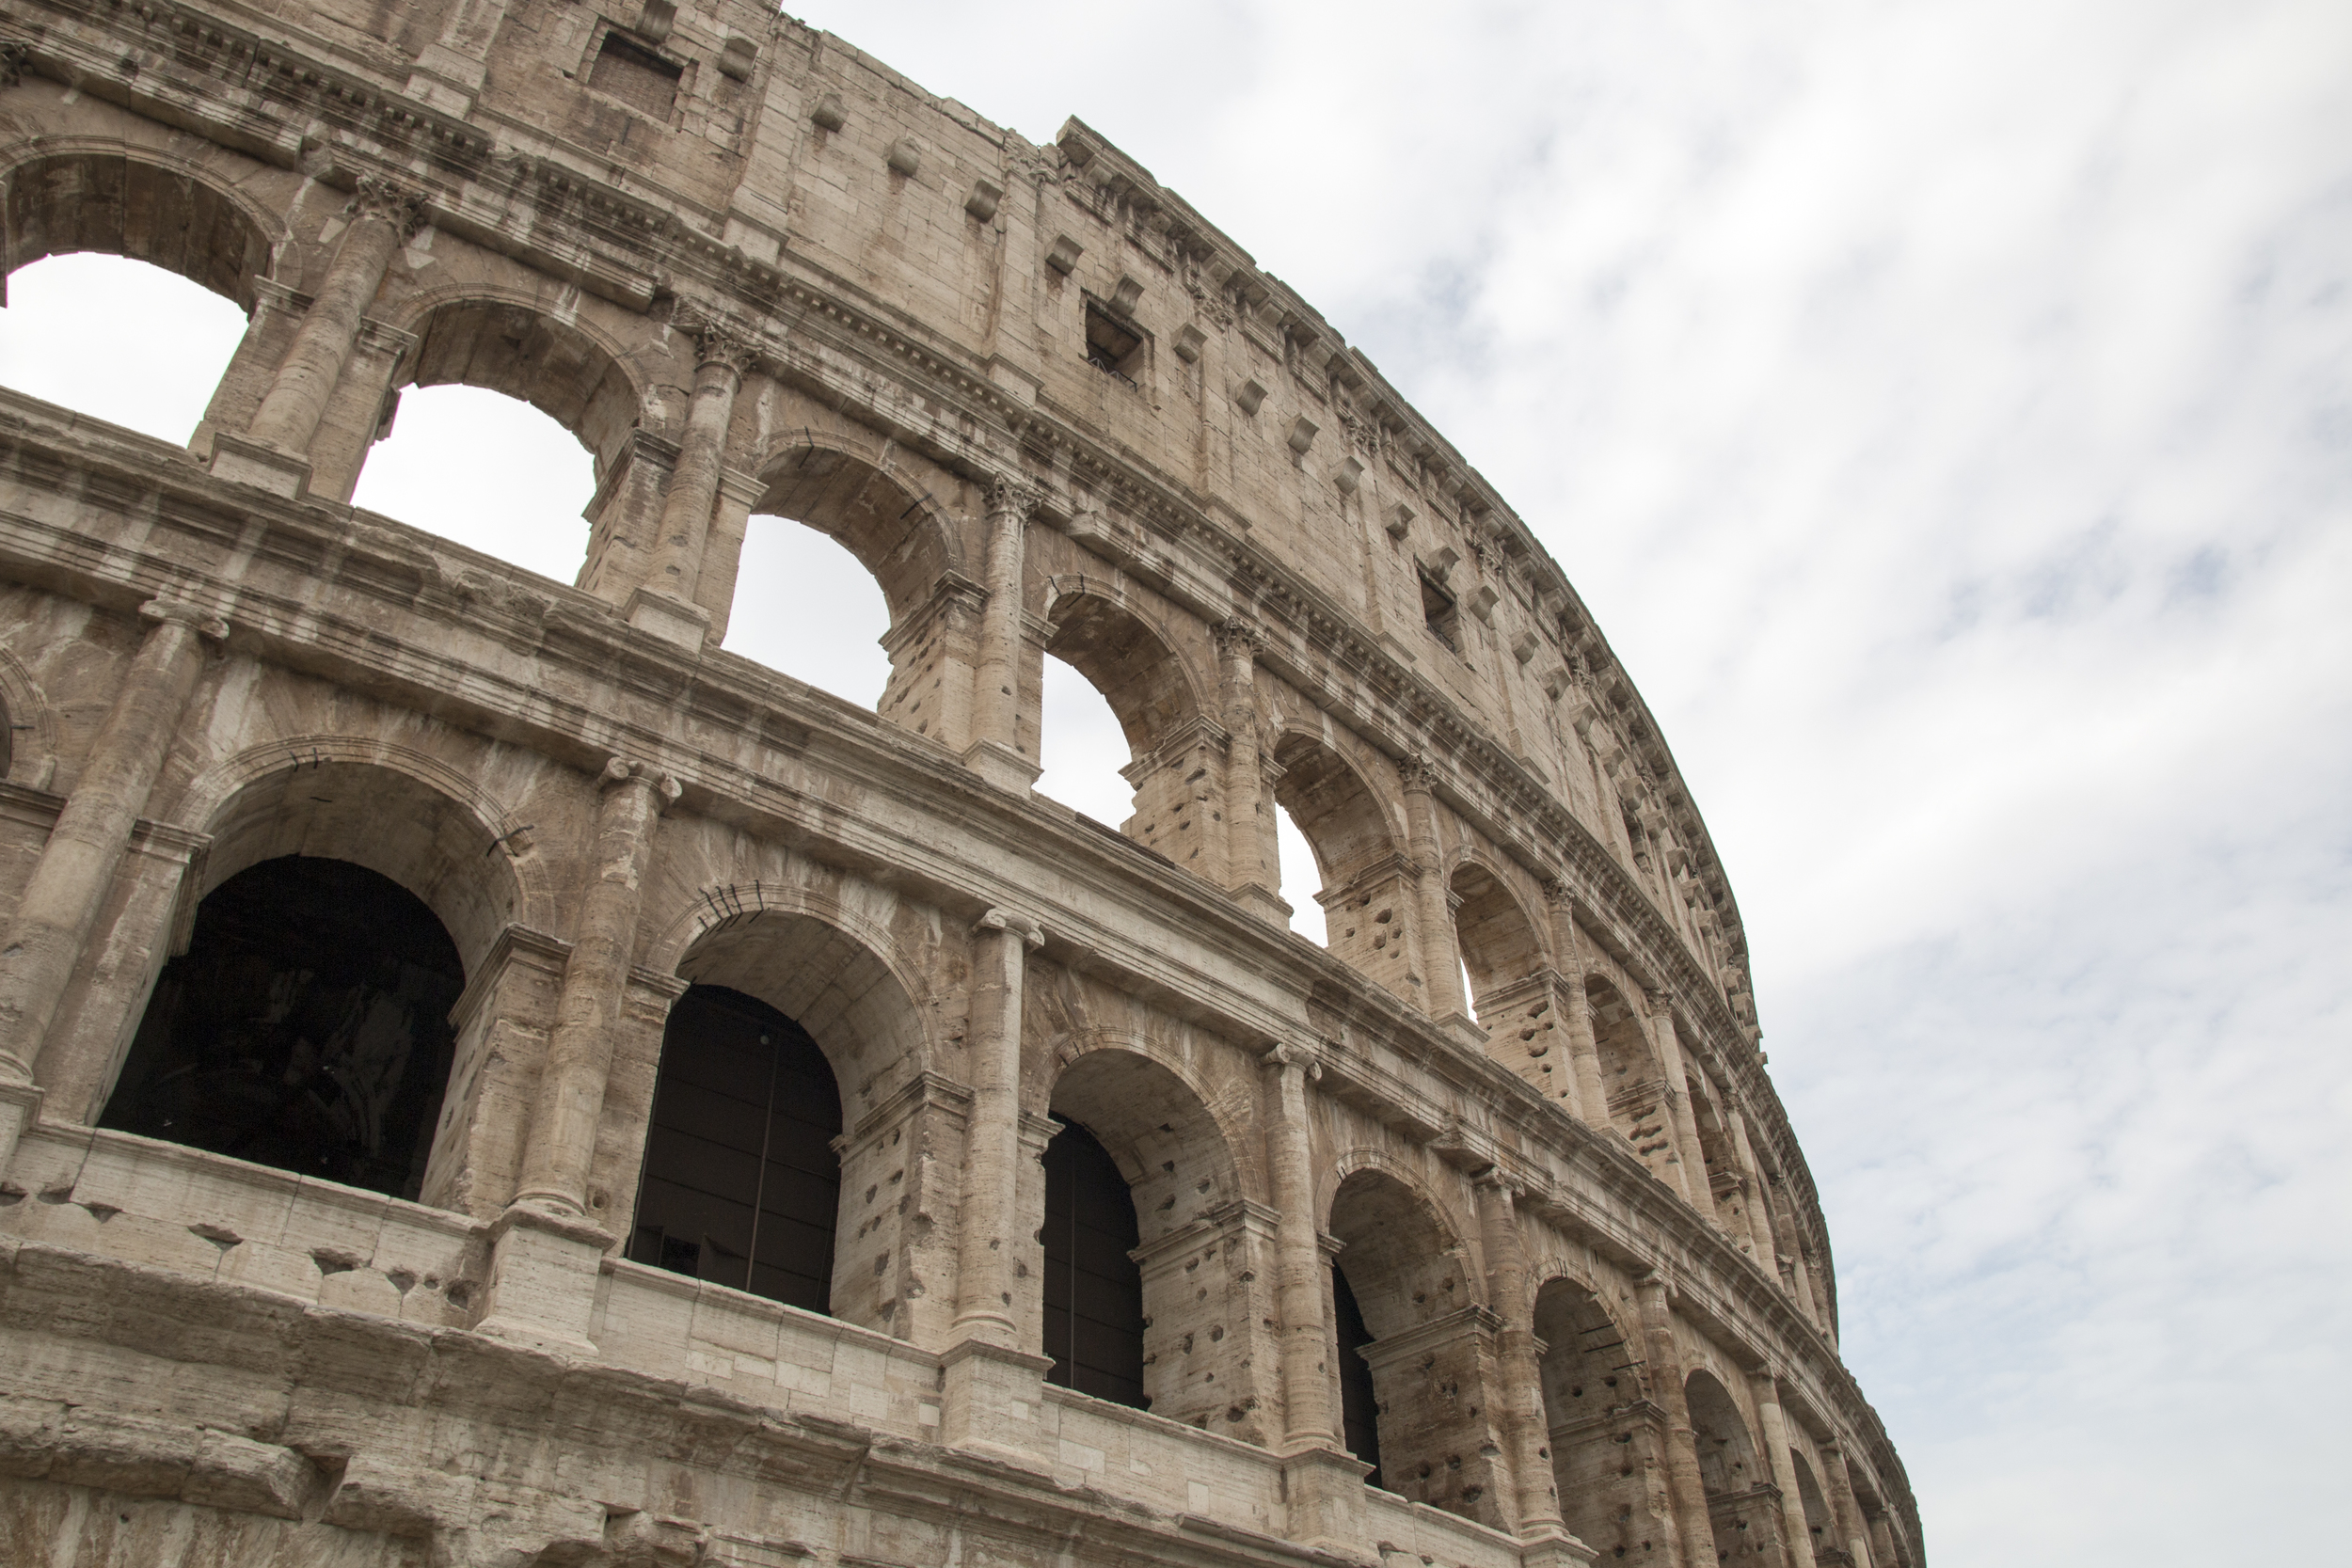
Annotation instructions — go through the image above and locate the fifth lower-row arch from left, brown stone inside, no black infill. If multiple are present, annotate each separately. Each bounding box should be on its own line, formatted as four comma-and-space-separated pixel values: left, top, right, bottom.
1536, 1279, 1673, 1563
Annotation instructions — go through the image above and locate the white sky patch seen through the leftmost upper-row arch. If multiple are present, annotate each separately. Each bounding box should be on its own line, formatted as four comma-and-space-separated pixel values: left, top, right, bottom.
0, 254, 245, 442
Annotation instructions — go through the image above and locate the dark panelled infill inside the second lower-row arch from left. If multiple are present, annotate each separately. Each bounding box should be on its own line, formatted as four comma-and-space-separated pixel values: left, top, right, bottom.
628, 985, 842, 1312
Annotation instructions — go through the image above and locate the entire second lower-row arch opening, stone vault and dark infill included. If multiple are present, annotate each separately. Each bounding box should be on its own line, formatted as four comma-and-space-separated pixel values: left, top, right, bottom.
673, 907, 936, 1338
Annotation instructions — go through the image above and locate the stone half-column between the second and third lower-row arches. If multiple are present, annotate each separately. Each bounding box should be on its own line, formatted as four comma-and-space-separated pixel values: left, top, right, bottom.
955, 910, 1044, 1350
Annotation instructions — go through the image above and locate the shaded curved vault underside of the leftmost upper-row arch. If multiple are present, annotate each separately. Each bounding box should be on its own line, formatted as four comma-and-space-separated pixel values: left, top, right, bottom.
0, 152, 271, 312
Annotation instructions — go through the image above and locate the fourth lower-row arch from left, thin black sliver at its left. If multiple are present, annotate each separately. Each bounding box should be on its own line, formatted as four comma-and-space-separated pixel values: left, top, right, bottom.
1331, 1168, 1501, 1524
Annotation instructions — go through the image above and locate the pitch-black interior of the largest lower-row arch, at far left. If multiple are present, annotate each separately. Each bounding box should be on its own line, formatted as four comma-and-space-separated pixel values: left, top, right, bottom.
99, 856, 466, 1199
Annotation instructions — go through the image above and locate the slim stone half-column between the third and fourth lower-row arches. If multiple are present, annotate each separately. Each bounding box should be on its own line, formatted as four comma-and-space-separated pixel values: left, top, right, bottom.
1265, 1044, 1339, 1450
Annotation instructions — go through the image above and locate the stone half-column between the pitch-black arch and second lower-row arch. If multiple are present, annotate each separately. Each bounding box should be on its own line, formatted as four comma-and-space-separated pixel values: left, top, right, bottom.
516, 757, 677, 1218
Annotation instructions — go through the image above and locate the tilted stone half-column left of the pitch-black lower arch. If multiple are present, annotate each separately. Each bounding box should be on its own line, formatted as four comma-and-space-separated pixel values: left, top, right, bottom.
0, 599, 229, 1084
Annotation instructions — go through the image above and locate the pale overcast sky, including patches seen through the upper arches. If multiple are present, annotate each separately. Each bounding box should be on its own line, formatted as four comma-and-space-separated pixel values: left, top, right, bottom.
0, 0, 2352, 1568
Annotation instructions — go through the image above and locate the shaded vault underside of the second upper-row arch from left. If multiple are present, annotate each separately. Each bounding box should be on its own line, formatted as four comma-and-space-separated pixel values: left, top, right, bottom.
409, 301, 638, 477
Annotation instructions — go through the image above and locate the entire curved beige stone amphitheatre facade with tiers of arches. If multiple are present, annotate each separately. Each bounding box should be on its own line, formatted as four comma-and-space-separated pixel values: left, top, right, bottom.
0, 0, 1924, 1568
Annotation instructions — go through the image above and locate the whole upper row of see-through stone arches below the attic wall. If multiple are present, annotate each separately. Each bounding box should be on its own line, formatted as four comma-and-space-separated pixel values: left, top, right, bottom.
5, 137, 1816, 1325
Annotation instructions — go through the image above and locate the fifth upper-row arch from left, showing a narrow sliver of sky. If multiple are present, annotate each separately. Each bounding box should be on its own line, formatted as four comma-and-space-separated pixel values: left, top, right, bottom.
1275, 731, 1416, 999
